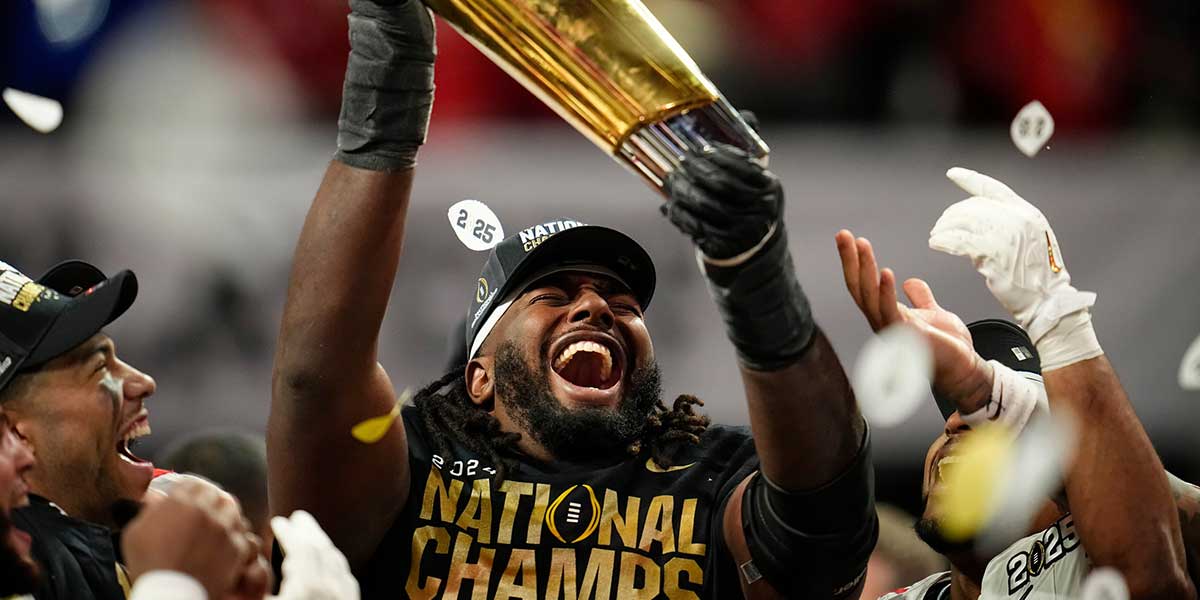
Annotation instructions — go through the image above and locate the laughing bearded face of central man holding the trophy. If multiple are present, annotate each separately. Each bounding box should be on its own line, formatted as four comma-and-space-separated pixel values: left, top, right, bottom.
467, 271, 659, 457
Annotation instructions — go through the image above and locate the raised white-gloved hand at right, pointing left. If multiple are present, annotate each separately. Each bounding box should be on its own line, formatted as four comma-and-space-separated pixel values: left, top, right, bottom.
929, 167, 1096, 343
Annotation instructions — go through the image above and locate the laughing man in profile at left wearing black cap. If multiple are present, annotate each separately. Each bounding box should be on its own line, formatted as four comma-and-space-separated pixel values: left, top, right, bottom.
0, 260, 269, 600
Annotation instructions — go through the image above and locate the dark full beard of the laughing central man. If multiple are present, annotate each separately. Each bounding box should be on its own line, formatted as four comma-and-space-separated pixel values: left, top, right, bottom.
496, 342, 662, 461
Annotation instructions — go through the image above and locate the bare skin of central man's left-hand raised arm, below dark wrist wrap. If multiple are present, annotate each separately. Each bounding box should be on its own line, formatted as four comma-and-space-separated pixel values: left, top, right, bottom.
266, 161, 412, 564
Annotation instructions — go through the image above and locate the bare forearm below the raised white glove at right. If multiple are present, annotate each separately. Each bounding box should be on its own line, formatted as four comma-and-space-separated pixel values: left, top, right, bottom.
1045, 356, 1194, 598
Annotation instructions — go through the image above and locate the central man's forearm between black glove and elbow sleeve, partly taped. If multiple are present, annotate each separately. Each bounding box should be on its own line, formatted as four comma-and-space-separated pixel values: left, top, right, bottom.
704, 224, 864, 491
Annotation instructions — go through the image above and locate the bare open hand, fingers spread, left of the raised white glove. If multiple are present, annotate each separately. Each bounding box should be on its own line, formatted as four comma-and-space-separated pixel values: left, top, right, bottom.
834, 229, 989, 412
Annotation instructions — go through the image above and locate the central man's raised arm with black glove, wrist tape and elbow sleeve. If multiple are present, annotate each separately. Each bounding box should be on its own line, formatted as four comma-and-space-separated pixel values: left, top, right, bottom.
662, 146, 877, 598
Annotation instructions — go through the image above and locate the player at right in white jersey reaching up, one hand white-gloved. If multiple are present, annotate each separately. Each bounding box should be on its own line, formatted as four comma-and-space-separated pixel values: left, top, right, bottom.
836, 169, 1195, 600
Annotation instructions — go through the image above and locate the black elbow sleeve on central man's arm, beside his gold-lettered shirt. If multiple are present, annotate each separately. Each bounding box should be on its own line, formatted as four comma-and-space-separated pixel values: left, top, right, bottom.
739, 430, 880, 599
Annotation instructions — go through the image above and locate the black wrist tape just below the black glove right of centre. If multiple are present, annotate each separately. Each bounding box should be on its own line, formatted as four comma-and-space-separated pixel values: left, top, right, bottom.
704, 223, 816, 371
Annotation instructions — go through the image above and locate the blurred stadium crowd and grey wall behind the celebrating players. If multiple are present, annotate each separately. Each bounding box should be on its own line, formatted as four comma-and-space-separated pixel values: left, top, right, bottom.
0, 0, 1200, 518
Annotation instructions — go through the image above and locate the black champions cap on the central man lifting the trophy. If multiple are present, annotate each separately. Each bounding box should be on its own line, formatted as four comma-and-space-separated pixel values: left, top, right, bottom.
466, 218, 655, 360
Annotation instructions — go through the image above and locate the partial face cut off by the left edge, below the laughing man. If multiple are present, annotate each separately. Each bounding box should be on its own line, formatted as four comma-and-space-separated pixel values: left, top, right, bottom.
0, 410, 38, 596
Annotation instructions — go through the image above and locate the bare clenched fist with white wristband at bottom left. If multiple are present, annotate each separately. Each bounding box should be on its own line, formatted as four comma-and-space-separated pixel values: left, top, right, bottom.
121, 481, 258, 599
